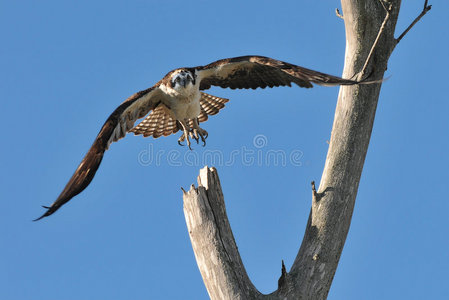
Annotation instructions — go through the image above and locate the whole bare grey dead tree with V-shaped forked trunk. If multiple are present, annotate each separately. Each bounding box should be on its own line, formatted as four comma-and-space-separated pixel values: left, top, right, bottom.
184, 0, 431, 299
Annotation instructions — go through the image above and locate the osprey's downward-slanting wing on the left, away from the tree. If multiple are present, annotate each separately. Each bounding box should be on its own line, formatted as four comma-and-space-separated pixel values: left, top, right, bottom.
34, 85, 163, 221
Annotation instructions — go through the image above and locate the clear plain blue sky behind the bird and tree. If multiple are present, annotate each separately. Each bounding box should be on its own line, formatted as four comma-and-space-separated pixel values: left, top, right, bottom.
0, 0, 449, 300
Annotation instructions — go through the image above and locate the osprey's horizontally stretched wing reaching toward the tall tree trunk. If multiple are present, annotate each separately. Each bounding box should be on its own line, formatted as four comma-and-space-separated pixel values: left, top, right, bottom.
196, 56, 367, 90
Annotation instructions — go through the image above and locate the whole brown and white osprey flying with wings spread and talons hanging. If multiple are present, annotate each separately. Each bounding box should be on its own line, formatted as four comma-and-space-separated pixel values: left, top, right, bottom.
35, 56, 372, 221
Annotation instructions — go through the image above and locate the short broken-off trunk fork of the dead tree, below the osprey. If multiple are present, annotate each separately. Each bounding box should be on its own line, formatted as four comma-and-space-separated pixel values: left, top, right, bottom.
184, 167, 260, 299
